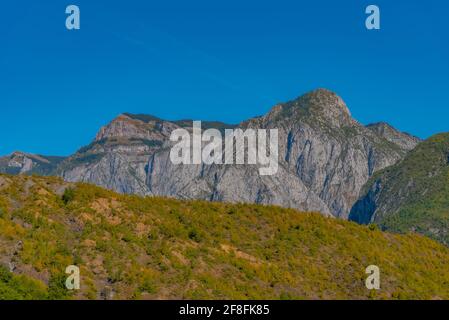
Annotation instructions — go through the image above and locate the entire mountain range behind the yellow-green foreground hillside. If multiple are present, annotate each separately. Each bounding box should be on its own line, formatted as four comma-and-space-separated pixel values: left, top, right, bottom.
0, 89, 449, 243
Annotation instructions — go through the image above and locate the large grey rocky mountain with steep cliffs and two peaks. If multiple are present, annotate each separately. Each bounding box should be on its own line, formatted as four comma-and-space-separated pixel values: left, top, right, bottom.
0, 89, 419, 218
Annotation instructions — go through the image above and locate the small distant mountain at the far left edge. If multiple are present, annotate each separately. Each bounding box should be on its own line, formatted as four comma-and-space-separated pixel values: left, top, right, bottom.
0, 152, 64, 175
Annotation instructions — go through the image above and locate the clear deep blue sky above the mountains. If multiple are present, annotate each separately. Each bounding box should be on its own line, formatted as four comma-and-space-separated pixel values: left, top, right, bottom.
0, 0, 449, 155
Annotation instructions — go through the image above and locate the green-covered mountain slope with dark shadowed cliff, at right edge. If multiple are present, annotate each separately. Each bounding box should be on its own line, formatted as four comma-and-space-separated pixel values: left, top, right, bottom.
349, 133, 449, 245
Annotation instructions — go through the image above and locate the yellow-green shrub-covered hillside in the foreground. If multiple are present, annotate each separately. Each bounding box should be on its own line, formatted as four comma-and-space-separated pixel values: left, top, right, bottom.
0, 175, 449, 299
